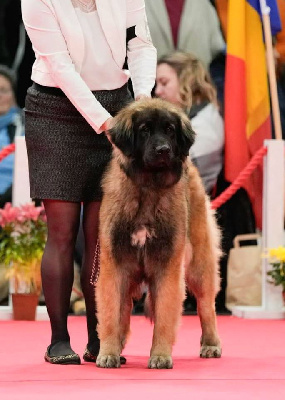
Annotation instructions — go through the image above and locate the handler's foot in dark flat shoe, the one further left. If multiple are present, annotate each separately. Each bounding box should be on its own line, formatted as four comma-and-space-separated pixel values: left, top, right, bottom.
45, 341, 81, 365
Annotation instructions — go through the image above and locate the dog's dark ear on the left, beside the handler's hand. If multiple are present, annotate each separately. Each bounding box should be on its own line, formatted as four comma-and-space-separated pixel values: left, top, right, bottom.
109, 114, 134, 157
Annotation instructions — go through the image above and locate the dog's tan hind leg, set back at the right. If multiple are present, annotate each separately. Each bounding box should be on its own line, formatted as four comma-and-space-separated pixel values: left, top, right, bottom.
186, 192, 222, 358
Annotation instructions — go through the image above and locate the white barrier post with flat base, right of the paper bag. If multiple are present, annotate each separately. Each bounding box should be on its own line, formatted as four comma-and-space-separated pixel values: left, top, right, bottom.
232, 140, 285, 319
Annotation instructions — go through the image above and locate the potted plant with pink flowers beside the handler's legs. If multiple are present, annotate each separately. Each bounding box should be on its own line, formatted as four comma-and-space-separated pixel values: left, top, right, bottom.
0, 203, 47, 319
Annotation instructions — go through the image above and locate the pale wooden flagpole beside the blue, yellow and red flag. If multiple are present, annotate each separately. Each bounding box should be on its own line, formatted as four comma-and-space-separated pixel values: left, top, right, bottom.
259, 0, 282, 140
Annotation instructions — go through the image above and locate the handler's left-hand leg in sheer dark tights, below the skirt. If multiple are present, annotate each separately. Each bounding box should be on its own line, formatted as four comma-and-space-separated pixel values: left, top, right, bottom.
42, 200, 81, 356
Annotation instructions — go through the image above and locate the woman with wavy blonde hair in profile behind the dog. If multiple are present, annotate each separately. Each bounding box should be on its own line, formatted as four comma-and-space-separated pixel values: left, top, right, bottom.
155, 52, 224, 194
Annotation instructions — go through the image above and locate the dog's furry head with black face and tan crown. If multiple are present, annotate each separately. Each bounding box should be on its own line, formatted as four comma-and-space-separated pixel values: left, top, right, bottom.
107, 99, 195, 187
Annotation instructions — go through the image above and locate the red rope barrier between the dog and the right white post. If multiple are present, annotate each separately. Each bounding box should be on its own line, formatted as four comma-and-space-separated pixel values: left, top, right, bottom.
211, 147, 267, 210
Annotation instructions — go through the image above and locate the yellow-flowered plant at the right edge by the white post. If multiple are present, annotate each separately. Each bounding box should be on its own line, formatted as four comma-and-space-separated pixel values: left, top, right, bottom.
267, 246, 285, 304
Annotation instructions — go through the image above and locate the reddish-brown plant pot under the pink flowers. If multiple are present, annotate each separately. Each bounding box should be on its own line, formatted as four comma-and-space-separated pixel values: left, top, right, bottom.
12, 293, 39, 321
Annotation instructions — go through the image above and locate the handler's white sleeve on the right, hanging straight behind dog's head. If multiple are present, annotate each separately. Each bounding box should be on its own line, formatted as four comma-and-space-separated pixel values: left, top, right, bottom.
127, 0, 157, 97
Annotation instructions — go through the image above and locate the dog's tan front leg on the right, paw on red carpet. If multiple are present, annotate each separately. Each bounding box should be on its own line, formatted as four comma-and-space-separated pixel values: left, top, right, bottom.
148, 259, 185, 369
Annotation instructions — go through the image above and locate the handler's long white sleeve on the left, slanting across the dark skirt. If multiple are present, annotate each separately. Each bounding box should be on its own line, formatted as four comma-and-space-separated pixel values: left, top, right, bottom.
22, 0, 111, 133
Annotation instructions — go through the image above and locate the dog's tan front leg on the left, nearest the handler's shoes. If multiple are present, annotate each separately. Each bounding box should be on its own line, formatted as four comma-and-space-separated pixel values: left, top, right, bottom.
95, 247, 125, 368
